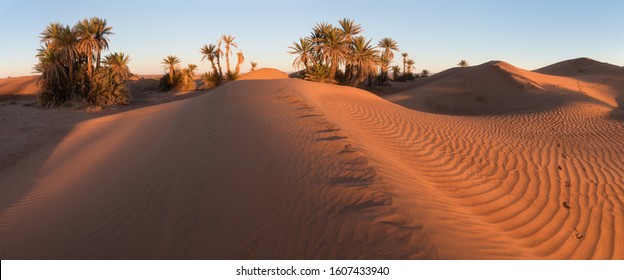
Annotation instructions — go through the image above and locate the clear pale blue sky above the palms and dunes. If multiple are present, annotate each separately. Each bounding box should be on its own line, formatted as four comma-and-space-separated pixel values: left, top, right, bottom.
0, 0, 624, 78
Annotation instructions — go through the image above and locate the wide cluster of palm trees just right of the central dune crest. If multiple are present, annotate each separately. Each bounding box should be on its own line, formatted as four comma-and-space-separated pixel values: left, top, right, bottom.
288, 18, 414, 86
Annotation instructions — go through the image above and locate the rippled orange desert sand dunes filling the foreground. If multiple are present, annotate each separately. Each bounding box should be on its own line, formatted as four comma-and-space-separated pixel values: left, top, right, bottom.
0, 59, 624, 259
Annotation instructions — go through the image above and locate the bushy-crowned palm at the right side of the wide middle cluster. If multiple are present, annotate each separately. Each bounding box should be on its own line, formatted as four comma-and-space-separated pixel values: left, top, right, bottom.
349, 36, 379, 86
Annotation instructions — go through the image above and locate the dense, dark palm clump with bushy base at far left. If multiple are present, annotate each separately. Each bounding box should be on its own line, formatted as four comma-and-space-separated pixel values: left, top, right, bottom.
34, 17, 131, 107
